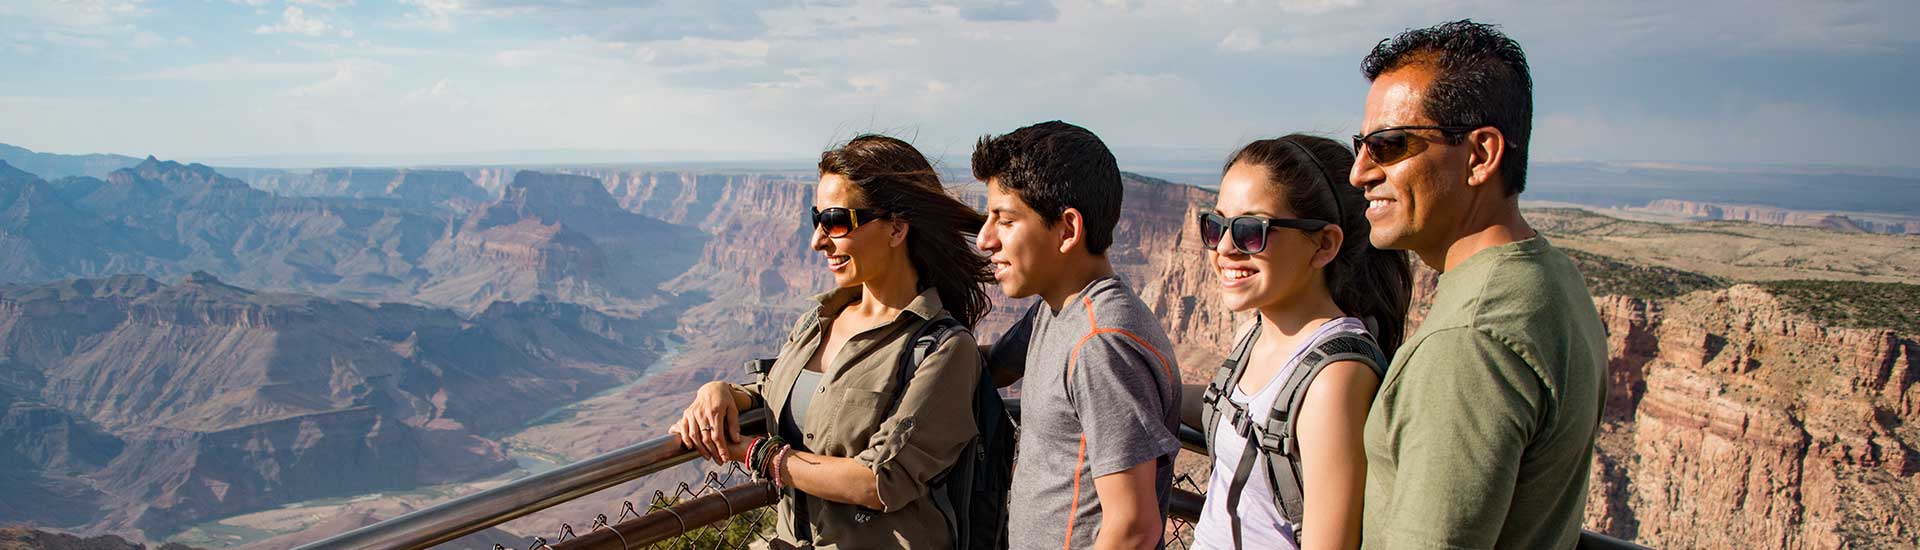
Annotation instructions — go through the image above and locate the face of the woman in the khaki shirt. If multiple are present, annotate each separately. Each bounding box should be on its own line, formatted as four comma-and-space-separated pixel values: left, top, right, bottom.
812, 173, 904, 288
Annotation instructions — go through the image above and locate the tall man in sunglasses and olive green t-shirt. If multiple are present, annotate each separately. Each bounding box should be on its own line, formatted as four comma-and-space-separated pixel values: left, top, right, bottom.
1350, 21, 1607, 548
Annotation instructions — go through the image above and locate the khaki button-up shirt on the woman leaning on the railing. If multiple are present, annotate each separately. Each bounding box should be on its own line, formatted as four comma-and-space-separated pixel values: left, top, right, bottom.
741, 288, 981, 548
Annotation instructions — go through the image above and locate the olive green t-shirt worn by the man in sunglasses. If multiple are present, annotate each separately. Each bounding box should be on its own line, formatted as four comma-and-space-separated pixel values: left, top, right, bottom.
1363, 237, 1607, 548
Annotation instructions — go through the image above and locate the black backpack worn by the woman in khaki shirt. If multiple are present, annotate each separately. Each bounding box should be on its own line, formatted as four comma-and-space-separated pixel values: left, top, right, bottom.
747, 312, 1016, 550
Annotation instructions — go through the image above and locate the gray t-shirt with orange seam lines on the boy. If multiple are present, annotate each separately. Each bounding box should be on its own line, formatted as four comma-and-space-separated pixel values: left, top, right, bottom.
1008, 277, 1181, 550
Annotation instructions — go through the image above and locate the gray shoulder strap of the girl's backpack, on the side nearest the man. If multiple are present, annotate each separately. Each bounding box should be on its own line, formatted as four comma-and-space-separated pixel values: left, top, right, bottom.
1260, 331, 1386, 540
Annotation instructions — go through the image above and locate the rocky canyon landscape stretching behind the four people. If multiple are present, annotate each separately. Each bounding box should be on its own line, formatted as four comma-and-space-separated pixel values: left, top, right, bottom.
0, 160, 1920, 548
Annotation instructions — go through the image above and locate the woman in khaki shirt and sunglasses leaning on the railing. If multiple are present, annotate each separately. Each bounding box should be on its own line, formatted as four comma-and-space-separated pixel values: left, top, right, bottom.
670, 135, 993, 548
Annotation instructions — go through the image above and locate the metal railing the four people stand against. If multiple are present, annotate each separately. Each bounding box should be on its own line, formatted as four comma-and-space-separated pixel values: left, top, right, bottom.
300, 398, 1645, 550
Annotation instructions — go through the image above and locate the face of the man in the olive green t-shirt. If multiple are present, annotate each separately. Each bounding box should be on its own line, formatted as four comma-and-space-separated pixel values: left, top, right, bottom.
1348, 63, 1471, 252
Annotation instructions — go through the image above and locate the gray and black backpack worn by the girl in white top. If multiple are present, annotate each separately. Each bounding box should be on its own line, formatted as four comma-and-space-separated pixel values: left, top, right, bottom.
1200, 321, 1386, 548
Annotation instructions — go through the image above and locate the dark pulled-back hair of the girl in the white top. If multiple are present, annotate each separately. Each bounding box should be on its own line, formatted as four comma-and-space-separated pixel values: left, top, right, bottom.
1223, 135, 1413, 358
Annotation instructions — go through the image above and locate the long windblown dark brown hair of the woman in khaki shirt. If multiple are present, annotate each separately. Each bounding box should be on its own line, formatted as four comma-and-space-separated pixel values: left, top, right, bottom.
820, 135, 993, 327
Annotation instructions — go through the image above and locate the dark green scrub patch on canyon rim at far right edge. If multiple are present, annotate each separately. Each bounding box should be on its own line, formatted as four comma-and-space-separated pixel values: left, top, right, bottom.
1759, 281, 1920, 335
